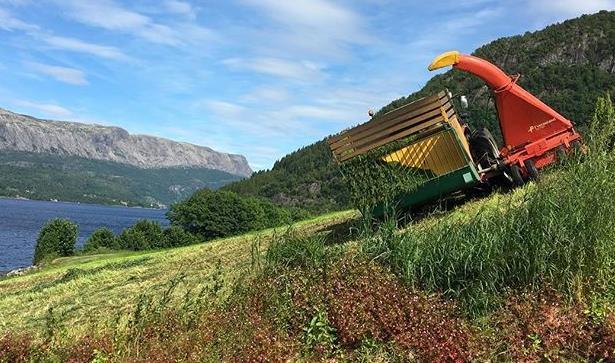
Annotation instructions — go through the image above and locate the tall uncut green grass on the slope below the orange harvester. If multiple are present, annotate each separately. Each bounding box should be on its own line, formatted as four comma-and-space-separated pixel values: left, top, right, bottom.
363, 94, 615, 314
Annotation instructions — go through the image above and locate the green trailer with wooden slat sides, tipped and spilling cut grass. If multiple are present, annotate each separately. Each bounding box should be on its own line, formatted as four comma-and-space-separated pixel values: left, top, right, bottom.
328, 92, 480, 216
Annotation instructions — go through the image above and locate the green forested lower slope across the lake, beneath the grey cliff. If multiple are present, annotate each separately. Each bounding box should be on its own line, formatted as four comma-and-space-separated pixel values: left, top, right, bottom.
0, 152, 241, 207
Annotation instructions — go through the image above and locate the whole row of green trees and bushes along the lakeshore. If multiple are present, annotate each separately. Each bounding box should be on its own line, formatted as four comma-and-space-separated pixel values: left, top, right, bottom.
33, 189, 310, 264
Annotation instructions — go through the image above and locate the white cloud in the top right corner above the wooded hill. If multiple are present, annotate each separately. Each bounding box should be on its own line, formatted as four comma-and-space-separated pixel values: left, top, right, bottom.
528, 0, 615, 17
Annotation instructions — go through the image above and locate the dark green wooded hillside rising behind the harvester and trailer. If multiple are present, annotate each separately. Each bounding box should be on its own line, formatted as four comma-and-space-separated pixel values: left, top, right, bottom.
226, 11, 615, 211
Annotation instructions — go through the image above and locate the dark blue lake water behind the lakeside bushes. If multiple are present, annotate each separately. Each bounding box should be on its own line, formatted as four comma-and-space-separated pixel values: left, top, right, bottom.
0, 199, 169, 272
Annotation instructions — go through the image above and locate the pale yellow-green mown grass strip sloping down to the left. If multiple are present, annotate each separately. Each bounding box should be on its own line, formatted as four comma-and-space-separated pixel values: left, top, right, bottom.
0, 211, 357, 335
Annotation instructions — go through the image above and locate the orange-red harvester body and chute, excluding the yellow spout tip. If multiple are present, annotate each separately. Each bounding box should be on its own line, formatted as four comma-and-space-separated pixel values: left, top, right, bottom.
452, 54, 580, 175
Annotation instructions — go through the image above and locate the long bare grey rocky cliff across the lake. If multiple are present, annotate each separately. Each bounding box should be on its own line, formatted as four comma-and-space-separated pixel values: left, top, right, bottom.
0, 109, 252, 176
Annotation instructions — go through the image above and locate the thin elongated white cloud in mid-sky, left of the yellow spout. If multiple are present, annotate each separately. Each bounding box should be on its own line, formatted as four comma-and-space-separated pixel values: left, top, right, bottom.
222, 58, 323, 81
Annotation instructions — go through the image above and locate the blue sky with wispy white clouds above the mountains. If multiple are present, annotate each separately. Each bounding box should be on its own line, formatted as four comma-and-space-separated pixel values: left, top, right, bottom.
0, 0, 615, 169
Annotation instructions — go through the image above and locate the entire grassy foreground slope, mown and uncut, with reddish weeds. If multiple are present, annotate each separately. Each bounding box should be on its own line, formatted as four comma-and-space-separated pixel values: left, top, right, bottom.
0, 142, 615, 362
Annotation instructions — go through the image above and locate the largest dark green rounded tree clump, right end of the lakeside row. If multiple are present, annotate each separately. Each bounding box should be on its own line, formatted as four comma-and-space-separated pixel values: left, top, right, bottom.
167, 189, 292, 239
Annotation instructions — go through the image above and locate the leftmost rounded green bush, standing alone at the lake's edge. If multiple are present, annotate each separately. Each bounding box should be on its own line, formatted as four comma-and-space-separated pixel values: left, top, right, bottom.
34, 219, 78, 264
